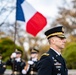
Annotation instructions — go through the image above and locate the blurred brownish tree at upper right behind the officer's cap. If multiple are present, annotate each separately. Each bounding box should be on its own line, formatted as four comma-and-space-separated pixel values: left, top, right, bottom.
52, 0, 76, 35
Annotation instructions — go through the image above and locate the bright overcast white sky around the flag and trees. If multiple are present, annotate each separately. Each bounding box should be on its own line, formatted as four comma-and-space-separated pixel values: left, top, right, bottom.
0, 0, 69, 36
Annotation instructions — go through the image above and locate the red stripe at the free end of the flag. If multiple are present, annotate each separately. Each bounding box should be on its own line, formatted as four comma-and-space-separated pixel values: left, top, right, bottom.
26, 12, 47, 36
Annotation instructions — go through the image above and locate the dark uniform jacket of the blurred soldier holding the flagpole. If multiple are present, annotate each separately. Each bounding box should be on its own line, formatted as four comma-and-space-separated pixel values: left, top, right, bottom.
6, 58, 26, 75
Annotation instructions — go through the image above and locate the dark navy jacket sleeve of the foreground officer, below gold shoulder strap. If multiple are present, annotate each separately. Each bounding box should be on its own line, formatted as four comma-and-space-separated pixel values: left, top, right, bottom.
37, 57, 52, 75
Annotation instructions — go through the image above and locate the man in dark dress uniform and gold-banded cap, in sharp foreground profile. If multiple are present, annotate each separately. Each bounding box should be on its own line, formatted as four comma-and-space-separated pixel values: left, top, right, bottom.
37, 26, 68, 75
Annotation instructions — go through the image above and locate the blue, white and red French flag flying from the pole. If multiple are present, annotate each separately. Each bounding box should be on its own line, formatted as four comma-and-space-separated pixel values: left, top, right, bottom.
16, 0, 47, 36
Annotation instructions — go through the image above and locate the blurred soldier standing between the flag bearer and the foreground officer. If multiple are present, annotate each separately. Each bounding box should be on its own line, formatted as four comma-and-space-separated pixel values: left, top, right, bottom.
24, 48, 39, 75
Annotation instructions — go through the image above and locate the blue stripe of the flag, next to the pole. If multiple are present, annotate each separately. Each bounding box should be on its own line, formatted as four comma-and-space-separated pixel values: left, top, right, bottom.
16, 0, 25, 21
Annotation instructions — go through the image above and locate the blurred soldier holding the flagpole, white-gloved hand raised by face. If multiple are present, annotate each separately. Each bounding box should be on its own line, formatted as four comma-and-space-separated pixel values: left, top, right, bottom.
6, 51, 26, 75
